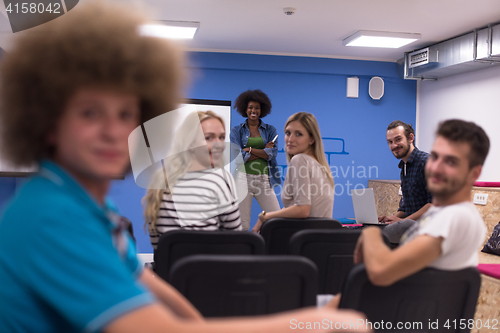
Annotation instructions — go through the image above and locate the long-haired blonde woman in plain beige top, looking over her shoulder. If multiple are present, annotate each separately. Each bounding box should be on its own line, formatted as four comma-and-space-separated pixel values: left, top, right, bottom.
252, 112, 334, 232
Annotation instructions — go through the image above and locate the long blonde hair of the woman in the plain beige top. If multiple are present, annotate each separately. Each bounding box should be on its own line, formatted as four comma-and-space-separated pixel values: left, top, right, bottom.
285, 112, 335, 187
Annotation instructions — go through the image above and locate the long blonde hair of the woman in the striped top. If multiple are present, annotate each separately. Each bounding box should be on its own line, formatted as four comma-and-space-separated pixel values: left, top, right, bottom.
141, 111, 225, 233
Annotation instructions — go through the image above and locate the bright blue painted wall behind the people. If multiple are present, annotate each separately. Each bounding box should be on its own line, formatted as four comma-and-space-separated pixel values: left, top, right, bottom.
0, 52, 416, 253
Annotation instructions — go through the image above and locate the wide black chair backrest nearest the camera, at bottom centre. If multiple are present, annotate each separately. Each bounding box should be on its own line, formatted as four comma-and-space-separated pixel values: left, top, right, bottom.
170, 255, 318, 317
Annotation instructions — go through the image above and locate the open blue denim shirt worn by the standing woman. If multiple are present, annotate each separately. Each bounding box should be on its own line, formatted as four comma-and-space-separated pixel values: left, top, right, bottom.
231, 120, 281, 187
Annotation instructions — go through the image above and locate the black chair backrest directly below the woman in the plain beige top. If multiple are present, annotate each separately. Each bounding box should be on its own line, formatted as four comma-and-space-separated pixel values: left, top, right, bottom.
260, 217, 342, 254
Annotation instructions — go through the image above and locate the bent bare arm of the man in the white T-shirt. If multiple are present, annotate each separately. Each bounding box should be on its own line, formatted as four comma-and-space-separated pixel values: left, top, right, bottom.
354, 227, 443, 286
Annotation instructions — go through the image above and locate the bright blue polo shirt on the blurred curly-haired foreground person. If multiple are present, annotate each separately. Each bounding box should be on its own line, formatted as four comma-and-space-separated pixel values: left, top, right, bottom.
0, 162, 154, 333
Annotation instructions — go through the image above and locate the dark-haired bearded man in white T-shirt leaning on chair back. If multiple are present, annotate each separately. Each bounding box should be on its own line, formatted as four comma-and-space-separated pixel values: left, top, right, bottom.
354, 119, 490, 286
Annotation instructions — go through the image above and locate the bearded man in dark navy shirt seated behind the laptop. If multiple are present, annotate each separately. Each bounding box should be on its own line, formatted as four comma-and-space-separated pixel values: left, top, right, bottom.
379, 120, 432, 223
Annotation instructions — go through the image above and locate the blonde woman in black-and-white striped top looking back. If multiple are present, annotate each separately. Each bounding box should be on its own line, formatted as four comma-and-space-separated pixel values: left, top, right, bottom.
143, 111, 241, 249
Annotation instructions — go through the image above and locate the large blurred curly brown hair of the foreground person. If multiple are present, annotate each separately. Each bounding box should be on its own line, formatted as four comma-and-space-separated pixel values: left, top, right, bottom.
0, 1, 182, 166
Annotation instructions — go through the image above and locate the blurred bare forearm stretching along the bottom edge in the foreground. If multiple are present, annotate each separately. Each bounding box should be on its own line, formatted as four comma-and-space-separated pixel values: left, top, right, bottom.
104, 303, 371, 333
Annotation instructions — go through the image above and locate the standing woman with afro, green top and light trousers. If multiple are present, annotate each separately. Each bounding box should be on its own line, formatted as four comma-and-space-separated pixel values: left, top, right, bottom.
231, 90, 281, 230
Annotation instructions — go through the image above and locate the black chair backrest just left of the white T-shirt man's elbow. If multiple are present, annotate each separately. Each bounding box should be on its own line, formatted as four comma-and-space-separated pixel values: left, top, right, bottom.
290, 229, 361, 294
